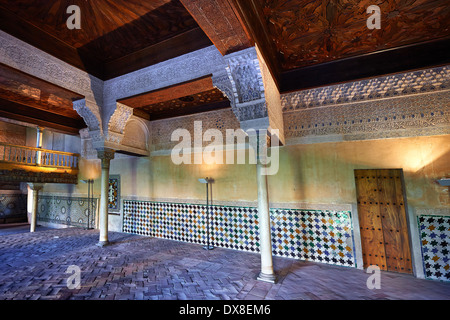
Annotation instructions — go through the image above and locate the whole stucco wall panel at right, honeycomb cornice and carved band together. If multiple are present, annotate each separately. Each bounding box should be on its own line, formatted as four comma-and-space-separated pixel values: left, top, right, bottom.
282, 66, 450, 144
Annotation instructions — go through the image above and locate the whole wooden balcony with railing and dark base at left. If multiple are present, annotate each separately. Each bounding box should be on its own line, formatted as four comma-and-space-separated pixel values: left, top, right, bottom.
0, 143, 80, 184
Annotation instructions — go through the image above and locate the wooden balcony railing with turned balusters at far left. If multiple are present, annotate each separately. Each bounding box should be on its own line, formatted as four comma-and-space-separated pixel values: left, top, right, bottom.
0, 143, 80, 169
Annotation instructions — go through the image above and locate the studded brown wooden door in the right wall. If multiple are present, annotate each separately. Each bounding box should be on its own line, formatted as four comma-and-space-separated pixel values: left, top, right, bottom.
355, 169, 412, 273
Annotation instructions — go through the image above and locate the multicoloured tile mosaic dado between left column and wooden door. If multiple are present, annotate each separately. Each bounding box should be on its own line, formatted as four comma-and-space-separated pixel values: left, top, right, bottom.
123, 200, 356, 267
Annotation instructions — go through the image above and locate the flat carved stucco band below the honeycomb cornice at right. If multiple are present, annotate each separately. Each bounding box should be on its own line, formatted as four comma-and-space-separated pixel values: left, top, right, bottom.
284, 87, 450, 144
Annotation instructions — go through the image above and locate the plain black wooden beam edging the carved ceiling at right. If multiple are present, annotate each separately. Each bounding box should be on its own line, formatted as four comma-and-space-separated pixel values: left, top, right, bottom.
280, 38, 450, 93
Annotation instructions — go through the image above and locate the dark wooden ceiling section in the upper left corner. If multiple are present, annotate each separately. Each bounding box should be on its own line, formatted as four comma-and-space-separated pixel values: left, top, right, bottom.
0, 0, 211, 80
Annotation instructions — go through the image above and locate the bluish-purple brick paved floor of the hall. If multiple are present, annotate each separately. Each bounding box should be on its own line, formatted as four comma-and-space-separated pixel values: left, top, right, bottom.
0, 225, 450, 300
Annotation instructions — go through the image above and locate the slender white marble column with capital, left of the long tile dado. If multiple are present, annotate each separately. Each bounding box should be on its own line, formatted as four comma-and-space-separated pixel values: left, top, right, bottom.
97, 148, 115, 247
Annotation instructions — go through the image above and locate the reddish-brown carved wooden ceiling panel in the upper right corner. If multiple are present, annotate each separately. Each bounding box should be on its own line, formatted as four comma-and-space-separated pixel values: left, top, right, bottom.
254, 0, 450, 70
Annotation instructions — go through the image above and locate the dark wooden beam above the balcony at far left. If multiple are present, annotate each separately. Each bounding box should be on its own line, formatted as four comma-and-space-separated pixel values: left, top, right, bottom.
0, 99, 86, 135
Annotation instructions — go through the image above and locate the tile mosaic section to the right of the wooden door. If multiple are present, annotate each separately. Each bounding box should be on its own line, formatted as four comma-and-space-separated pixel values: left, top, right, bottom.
417, 215, 450, 281
